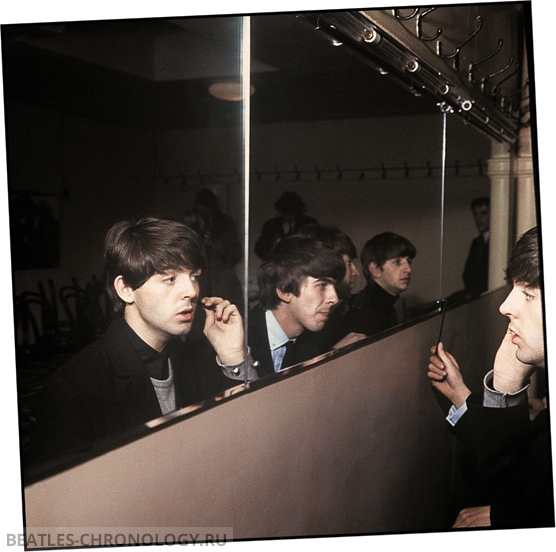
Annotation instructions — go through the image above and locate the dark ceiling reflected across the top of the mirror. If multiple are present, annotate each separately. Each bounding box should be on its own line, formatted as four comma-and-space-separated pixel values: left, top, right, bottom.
2, 14, 444, 130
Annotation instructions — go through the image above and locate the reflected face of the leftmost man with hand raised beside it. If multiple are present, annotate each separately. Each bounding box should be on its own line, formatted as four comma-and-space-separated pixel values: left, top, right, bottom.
124, 269, 201, 351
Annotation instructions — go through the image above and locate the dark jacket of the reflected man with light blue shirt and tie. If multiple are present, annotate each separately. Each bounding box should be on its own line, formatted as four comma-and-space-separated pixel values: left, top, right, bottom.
247, 306, 322, 377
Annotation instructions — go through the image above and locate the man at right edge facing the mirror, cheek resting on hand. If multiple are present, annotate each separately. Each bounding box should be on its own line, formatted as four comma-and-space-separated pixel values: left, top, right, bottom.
428, 228, 554, 529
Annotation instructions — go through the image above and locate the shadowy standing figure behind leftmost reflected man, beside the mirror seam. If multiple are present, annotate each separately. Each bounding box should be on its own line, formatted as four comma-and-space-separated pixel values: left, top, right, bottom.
183, 188, 243, 312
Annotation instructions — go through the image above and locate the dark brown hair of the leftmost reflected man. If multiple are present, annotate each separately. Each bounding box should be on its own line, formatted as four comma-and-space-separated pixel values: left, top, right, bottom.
104, 218, 206, 316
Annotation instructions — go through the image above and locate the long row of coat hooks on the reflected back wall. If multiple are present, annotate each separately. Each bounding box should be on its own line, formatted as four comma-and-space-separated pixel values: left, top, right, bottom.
157, 159, 487, 186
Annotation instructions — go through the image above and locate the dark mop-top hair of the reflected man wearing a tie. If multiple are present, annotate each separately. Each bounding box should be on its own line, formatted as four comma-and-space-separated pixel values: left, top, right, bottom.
257, 235, 346, 309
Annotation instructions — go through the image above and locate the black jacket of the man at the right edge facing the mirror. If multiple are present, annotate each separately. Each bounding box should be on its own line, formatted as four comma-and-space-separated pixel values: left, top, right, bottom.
452, 393, 554, 529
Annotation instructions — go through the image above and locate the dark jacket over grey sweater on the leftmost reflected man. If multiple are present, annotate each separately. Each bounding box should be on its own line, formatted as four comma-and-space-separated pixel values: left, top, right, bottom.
28, 320, 235, 465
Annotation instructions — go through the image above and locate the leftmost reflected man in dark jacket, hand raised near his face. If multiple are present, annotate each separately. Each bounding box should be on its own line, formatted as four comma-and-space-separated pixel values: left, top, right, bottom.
27, 218, 257, 465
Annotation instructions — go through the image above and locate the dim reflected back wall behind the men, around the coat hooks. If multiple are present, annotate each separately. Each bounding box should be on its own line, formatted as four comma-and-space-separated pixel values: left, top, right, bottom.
157, 113, 490, 305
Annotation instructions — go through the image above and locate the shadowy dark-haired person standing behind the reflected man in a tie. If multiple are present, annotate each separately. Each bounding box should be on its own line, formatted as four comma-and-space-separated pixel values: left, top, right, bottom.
254, 191, 318, 261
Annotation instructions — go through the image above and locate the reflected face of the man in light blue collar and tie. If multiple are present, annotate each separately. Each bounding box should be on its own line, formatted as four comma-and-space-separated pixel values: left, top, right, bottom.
284, 276, 338, 337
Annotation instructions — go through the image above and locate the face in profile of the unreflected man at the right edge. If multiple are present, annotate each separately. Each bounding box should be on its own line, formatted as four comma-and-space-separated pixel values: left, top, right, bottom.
500, 283, 545, 367
